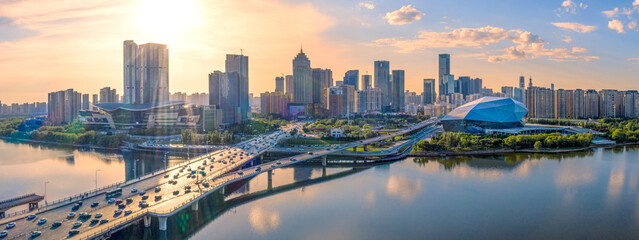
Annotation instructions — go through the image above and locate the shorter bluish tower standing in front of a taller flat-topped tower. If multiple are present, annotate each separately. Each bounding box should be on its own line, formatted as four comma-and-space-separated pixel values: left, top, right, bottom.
209, 71, 242, 125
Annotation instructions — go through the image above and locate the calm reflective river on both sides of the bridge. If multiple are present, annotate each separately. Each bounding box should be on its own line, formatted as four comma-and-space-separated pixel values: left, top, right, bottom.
0, 143, 639, 240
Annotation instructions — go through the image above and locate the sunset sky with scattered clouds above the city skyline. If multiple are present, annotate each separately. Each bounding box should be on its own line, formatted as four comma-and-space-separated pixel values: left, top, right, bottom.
0, 0, 639, 104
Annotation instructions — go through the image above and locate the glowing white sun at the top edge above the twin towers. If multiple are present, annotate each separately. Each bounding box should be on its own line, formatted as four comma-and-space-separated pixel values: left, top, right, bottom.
135, 0, 200, 44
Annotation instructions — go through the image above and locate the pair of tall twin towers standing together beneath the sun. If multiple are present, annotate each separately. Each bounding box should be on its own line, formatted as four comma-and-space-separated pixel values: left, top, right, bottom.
123, 40, 169, 104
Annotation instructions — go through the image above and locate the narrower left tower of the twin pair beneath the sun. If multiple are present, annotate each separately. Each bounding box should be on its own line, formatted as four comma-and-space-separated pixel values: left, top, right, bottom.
124, 40, 143, 104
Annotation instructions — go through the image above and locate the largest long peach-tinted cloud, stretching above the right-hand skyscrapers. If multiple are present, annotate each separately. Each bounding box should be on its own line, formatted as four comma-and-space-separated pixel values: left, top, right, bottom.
372, 26, 599, 62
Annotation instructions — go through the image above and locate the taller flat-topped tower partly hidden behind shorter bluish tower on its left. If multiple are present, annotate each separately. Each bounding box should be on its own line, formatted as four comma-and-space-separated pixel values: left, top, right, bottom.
225, 54, 251, 121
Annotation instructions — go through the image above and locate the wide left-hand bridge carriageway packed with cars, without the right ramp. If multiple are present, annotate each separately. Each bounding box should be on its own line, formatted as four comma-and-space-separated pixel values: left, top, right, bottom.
0, 123, 302, 239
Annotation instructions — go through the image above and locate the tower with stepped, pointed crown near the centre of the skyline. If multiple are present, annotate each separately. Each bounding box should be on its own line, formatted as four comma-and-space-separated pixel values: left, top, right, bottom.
293, 49, 313, 104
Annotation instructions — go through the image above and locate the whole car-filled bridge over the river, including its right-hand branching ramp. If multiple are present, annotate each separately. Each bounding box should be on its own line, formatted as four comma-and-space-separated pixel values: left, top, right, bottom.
0, 119, 437, 239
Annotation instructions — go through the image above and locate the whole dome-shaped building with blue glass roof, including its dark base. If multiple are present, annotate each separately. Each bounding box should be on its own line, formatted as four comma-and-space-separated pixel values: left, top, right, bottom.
441, 97, 528, 133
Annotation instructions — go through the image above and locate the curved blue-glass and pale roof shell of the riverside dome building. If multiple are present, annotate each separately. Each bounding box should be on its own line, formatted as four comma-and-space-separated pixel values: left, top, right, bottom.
442, 97, 528, 123
